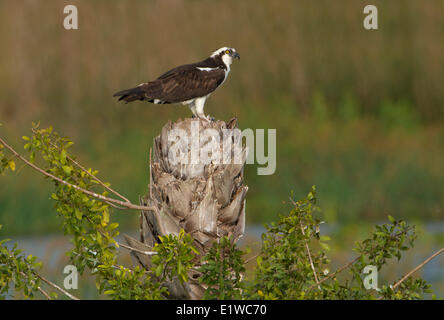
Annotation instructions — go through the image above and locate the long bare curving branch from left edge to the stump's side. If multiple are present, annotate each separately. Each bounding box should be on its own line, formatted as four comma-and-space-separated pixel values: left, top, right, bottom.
0, 138, 155, 211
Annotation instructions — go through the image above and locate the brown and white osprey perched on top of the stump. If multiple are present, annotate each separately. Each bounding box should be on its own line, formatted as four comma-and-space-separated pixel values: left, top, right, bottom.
114, 47, 240, 121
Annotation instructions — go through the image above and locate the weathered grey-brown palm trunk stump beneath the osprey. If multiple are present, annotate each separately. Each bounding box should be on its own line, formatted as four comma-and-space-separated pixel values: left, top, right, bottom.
127, 119, 248, 299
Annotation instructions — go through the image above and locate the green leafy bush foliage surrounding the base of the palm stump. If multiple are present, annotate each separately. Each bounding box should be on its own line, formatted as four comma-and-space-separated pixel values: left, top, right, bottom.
0, 125, 438, 299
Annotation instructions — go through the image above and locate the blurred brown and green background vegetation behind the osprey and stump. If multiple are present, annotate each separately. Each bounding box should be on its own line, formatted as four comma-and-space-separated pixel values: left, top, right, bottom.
0, 0, 444, 298
